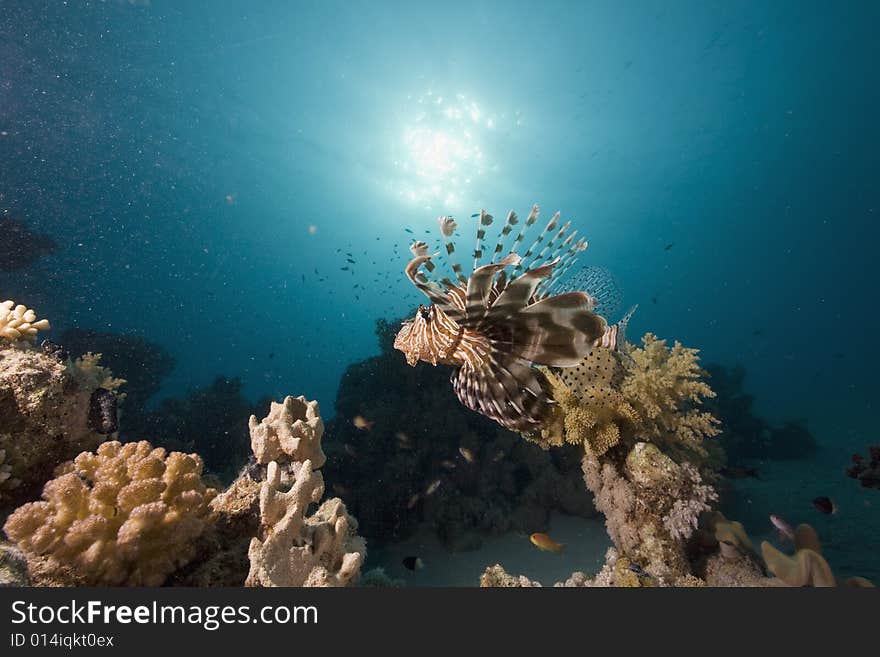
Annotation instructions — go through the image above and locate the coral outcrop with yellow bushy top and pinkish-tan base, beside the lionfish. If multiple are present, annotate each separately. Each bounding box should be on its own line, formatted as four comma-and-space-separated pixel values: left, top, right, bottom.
524, 333, 723, 585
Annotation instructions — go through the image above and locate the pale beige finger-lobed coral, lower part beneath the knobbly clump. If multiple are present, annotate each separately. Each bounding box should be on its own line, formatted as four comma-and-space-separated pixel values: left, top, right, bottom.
246, 458, 366, 586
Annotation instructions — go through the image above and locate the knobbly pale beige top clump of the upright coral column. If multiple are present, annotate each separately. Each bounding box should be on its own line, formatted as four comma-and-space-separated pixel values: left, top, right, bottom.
250, 396, 327, 468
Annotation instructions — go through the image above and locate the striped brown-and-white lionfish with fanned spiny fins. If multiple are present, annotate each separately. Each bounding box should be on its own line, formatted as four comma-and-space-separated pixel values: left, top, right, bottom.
394, 205, 631, 432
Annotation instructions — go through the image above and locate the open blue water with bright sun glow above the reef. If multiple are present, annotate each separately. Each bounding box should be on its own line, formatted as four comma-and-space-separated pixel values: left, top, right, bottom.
0, 0, 880, 580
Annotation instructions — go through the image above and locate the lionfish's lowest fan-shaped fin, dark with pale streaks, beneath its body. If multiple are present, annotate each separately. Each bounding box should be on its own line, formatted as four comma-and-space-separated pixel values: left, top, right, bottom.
451, 358, 550, 431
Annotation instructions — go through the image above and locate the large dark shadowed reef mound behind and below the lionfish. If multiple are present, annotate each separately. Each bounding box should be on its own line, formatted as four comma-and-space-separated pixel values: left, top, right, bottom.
323, 321, 595, 549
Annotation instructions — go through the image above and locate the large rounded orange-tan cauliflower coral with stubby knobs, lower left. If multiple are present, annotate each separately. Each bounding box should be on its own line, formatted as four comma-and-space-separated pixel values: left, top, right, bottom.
4, 441, 216, 586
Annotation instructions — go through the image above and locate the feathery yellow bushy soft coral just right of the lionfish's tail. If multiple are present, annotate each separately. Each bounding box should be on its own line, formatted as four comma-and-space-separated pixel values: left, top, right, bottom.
620, 333, 719, 456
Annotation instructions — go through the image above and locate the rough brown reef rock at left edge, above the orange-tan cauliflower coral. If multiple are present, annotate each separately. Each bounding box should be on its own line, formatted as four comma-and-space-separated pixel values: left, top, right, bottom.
0, 343, 122, 508
